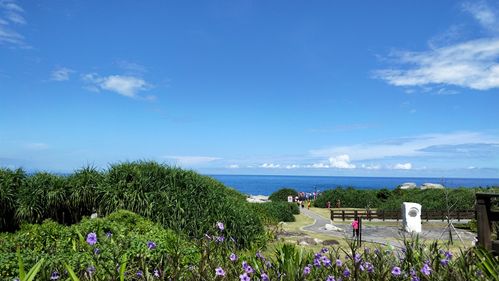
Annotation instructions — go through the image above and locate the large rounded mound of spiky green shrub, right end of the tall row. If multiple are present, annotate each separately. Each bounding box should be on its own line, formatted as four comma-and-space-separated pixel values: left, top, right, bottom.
98, 162, 264, 247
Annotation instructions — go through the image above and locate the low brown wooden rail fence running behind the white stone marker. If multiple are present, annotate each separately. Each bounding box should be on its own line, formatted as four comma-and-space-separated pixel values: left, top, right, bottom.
331, 209, 476, 221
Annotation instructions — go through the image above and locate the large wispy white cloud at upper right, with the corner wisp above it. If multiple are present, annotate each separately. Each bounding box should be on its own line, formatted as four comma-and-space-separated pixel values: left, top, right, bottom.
374, 2, 499, 91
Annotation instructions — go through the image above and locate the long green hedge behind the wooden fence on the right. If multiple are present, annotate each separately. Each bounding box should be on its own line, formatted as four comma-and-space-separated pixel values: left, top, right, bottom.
315, 188, 496, 210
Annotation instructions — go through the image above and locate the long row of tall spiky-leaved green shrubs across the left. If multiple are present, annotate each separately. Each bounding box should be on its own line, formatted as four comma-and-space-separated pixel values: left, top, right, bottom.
0, 161, 264, 247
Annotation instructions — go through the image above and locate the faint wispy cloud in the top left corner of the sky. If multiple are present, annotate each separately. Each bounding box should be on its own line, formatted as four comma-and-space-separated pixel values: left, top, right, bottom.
0, 0, 29, 48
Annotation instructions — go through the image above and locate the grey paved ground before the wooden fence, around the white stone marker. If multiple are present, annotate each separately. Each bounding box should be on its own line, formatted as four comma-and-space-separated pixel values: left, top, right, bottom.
300, 208, 475, 247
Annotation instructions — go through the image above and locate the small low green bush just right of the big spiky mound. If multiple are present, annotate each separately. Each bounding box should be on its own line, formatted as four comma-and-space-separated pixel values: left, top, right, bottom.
251, 201, 300, 224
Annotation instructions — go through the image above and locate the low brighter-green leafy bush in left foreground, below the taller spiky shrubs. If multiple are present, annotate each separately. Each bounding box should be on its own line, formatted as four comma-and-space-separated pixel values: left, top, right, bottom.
0, 211, 200, 280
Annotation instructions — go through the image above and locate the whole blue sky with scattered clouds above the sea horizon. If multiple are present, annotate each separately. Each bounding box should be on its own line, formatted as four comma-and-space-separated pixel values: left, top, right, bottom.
0, 0, 499, 178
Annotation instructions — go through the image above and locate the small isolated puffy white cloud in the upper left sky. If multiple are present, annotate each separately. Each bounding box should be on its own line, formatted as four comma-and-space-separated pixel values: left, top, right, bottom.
82, 73, 151, 98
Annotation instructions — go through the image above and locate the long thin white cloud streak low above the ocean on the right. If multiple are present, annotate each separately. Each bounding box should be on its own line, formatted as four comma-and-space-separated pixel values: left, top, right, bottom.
310, 132, 499, 161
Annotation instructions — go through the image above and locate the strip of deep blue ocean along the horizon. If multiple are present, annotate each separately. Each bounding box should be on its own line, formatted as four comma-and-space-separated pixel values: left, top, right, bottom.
210, 175, 499, 195
